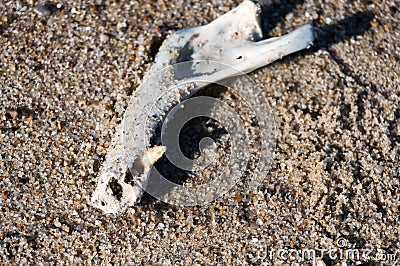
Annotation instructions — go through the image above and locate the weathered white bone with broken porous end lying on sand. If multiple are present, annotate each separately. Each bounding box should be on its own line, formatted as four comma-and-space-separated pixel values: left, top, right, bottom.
90, 1, 314, 213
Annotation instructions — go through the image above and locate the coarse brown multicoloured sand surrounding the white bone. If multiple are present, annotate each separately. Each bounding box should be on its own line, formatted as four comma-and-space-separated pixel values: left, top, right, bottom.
0, 0, 400, 265
